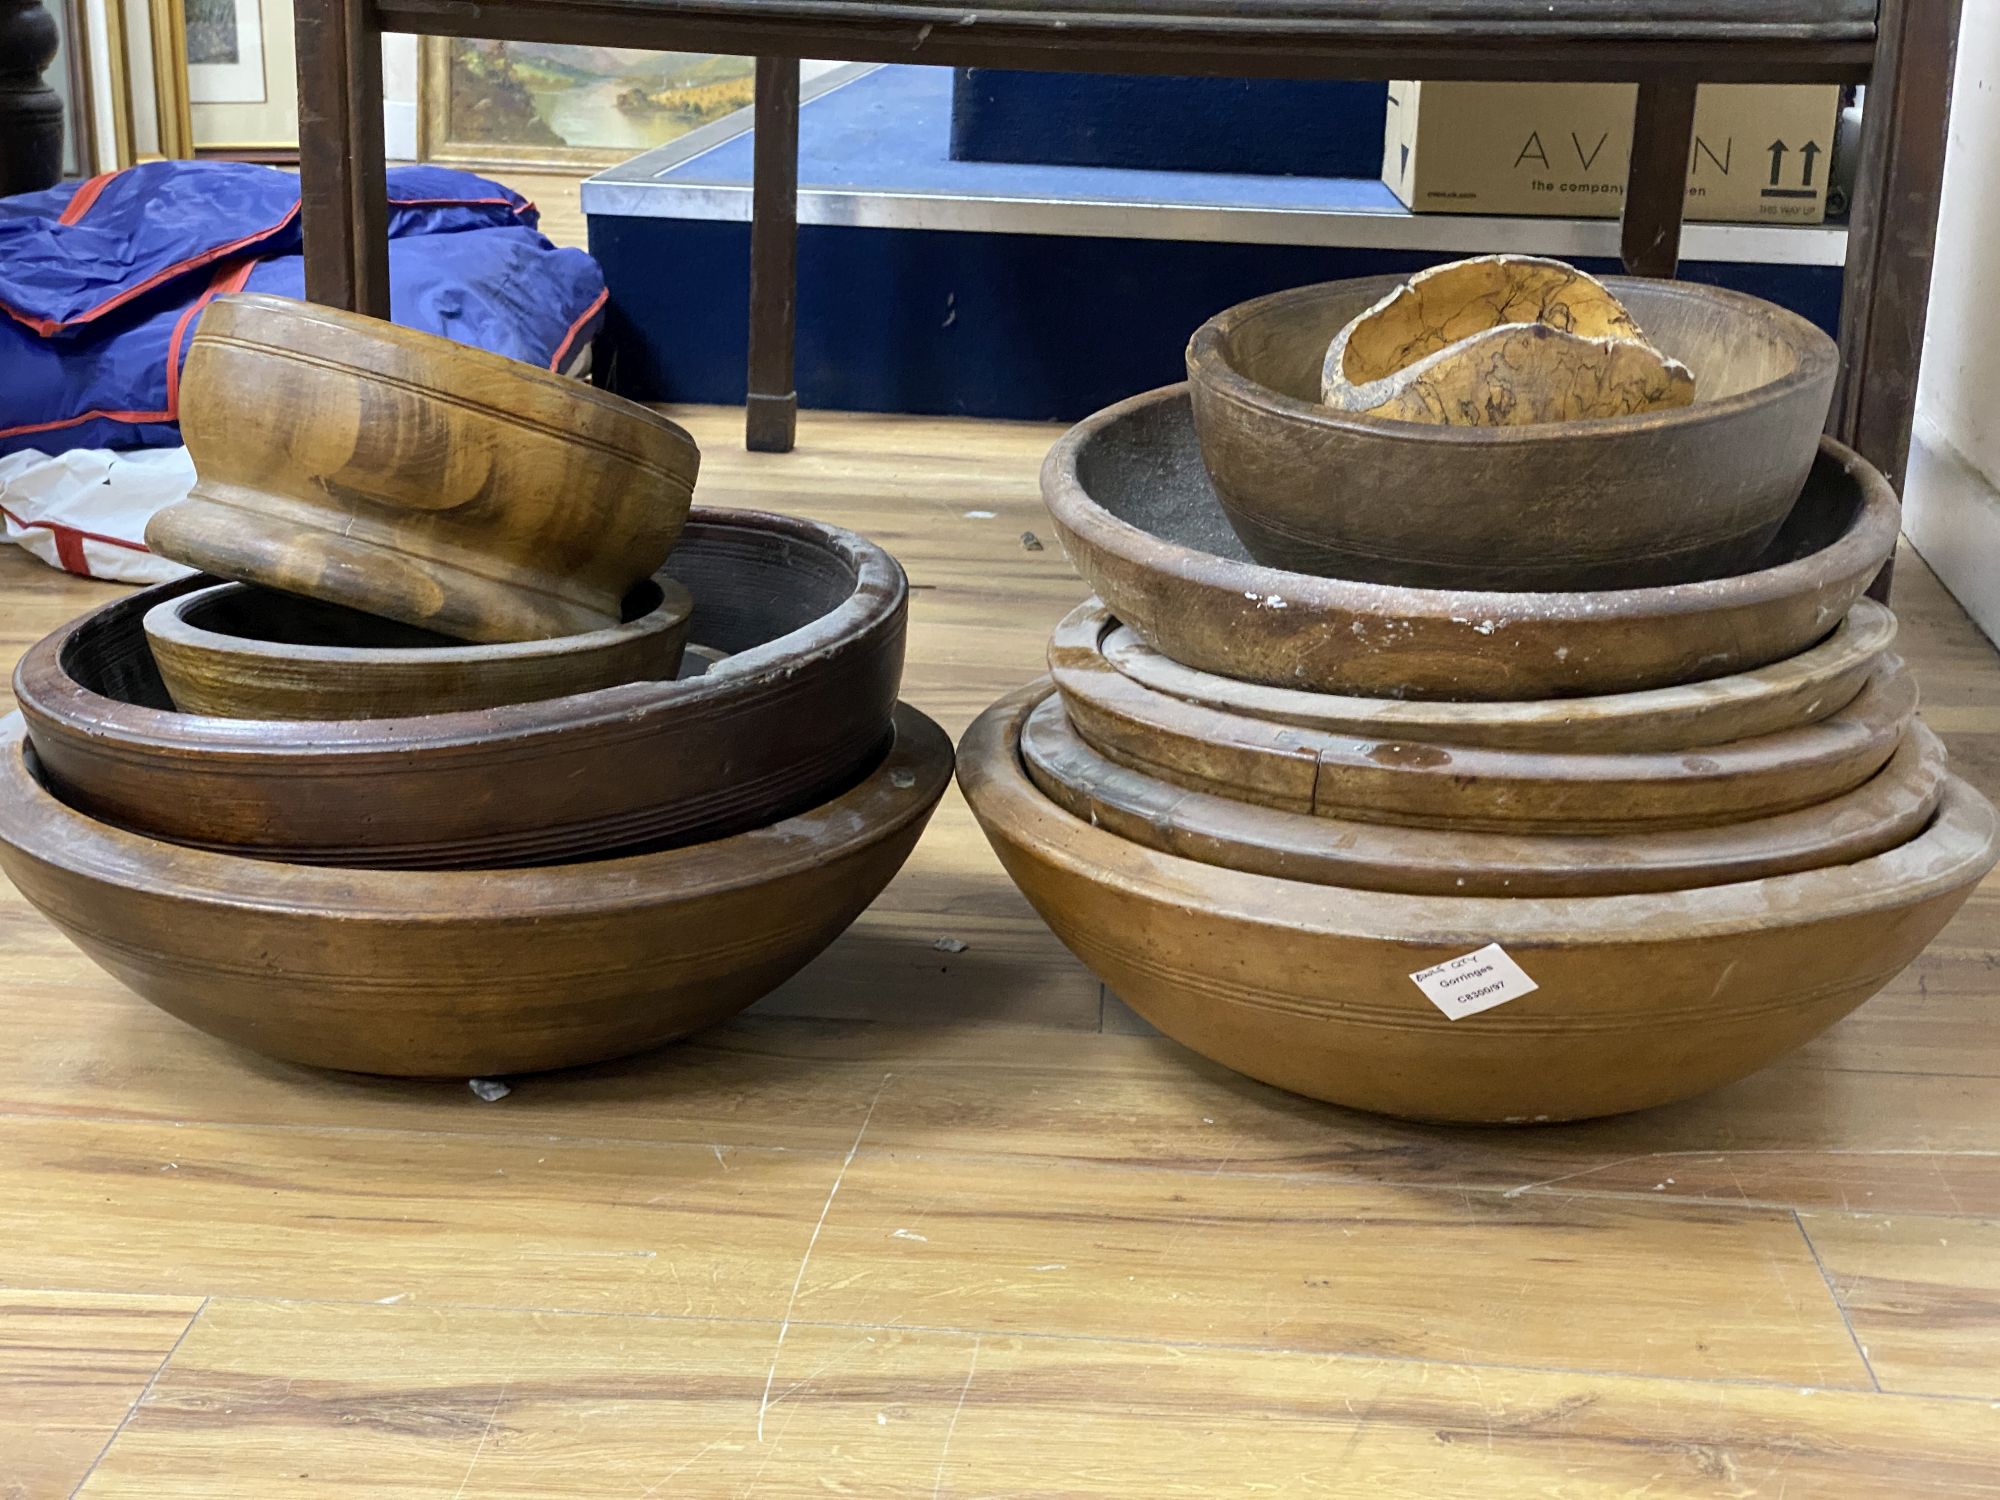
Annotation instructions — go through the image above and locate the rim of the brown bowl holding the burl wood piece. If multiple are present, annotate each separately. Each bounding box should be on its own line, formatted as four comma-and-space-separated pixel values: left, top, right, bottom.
1186, 274, 1840, 448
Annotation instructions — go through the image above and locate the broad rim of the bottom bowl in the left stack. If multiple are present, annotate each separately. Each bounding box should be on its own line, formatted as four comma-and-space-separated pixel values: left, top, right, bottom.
0, 702, 954, 928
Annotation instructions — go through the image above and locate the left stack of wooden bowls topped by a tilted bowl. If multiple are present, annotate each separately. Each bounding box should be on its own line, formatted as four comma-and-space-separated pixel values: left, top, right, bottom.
0, 298, 952, 1076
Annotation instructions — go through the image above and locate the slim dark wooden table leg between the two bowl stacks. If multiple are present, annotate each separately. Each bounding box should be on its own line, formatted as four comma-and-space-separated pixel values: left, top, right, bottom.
744, 58, 798, 454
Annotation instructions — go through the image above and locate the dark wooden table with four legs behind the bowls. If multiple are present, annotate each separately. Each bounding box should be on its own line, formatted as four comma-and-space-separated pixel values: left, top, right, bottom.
296, 0, 1960, 512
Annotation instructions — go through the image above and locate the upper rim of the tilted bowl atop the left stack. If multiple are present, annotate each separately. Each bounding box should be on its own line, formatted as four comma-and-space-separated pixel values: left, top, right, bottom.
201, 292, 702, 484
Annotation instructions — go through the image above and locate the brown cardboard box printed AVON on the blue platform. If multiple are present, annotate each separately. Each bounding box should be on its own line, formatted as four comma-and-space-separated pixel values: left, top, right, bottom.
1382, 82, 1840, 224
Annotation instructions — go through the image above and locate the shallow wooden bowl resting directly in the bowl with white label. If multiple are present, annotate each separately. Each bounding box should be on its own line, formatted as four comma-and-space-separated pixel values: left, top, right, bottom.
1020, 696, 1946, 896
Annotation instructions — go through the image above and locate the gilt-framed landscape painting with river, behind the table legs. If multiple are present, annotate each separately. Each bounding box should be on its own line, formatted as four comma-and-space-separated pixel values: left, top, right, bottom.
422, 40, 754, 168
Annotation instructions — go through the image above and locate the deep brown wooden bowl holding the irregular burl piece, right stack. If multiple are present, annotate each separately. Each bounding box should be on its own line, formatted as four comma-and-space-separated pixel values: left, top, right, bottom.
1188, 276, 1840, 590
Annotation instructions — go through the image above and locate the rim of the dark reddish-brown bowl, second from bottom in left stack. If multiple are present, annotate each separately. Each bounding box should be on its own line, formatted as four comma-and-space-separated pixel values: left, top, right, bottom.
14, 506, 908, 774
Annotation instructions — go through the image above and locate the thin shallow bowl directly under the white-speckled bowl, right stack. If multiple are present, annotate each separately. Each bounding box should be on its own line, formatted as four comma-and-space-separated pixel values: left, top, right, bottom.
1094, 598, 1896, 750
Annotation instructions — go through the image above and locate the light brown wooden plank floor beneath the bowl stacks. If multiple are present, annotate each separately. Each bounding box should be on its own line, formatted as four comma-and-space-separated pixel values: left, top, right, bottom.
0, 412, 2000, 1500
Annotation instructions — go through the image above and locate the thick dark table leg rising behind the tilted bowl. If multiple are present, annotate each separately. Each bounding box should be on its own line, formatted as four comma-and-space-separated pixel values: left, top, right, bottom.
296, 0, 388, 318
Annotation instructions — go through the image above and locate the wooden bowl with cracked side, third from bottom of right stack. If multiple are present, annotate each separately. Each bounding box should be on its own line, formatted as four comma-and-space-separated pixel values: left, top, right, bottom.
1048, 604, 1916, 834
